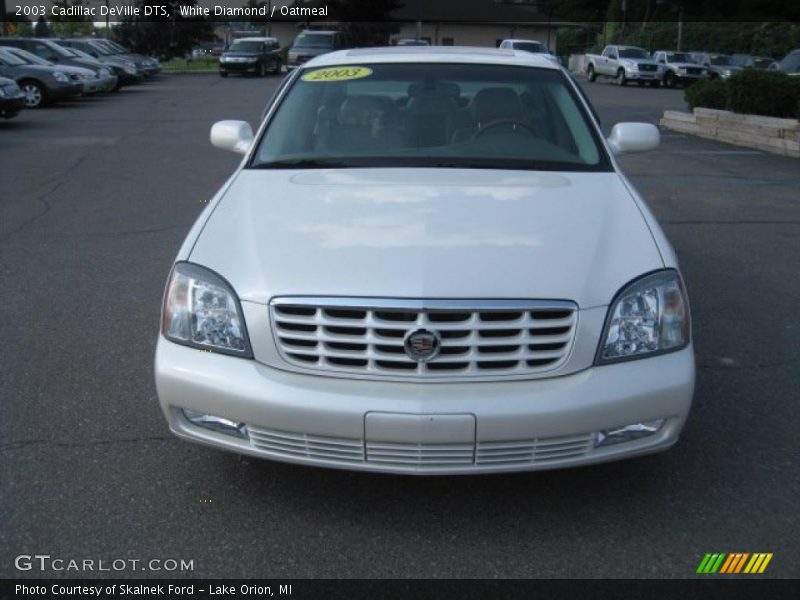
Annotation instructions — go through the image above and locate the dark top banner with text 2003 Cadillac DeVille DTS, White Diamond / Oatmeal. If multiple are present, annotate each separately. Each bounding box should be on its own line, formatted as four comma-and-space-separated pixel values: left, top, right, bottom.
0, 0, 800, 25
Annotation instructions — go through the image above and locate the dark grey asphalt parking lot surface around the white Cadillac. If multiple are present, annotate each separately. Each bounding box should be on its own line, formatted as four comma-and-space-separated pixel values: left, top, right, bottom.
0, 75, 800, 578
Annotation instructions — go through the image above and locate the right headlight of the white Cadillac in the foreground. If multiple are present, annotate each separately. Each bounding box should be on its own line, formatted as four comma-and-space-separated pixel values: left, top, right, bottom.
595, 269, 690, 364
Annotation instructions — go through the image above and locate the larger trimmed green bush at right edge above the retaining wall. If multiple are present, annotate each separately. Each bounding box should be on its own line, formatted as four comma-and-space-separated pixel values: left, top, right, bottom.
728, 69, 800, 118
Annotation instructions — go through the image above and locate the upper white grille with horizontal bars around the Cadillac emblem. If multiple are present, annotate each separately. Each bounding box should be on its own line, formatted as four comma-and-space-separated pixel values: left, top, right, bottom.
270, 297, 578, 380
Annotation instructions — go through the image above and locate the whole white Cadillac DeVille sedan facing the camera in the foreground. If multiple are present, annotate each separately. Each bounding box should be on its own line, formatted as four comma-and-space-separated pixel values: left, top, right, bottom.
155, 47, 695, 474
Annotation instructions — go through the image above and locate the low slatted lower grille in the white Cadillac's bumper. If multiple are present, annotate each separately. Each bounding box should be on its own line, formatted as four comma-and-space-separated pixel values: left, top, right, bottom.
247, 425, 597, 470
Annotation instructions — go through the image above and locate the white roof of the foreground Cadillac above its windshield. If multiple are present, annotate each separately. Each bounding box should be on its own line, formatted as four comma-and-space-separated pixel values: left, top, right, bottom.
303, 46, 561, 70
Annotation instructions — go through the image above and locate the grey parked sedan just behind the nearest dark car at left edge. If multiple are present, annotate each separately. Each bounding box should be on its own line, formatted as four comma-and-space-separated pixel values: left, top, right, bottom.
0, 48, 83, 108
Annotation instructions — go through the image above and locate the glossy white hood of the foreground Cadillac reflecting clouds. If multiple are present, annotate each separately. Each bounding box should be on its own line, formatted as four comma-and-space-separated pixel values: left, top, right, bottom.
189, 169, 664, 308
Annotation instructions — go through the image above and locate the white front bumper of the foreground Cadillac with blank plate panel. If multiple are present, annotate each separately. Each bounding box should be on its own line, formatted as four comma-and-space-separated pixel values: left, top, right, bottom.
155, 338, 695, 474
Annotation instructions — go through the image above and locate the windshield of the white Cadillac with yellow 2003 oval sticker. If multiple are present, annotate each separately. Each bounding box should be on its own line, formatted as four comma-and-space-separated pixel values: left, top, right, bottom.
251, 63, 609, 171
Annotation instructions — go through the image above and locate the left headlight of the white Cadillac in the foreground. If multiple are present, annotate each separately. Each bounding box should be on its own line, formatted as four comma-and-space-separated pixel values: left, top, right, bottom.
161, 262, 253, 358
